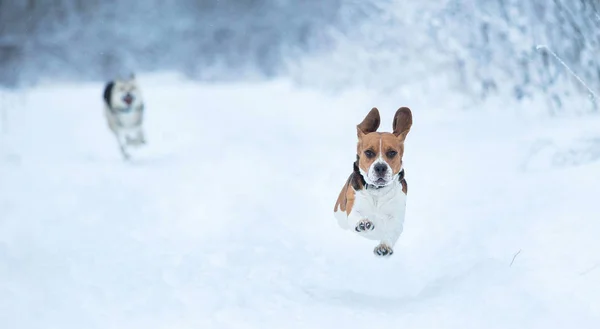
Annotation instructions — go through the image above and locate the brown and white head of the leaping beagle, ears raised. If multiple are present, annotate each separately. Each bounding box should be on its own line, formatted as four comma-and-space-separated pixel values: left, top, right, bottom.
356, 107, 412, 186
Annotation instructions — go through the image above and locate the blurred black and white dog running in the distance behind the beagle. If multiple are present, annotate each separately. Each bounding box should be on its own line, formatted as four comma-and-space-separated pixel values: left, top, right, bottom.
104, 74, 146, 159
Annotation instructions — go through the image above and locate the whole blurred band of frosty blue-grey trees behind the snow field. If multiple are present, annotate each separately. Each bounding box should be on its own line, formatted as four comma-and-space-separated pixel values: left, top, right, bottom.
0, 0, 600, 111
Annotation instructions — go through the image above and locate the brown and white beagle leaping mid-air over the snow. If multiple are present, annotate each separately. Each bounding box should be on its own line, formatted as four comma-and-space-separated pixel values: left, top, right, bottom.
334, 107, 412, 256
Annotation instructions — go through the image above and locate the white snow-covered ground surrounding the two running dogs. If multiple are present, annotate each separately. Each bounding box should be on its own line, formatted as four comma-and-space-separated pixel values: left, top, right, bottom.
0, 76, 600, 329
